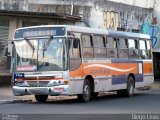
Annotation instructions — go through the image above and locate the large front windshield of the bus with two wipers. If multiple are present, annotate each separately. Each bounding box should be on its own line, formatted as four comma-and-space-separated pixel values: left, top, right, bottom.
15, 37, 67, 71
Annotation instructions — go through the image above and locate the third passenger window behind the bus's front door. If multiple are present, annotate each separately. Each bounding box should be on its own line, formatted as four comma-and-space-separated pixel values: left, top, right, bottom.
106, 37, 118, 58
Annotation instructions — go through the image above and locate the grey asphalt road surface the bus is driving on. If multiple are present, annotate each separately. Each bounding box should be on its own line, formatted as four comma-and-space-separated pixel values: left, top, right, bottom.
0, 85, 160, 120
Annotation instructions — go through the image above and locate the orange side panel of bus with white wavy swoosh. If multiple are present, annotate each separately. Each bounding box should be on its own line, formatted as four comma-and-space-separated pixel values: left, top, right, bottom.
70, 63, 139, 77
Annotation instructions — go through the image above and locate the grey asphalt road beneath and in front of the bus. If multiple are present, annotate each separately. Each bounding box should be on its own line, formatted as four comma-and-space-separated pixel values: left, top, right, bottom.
0, 86, 160, 120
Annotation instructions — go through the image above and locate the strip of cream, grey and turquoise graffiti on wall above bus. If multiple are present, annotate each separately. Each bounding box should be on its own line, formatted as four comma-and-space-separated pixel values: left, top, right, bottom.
103, 11, 160, 48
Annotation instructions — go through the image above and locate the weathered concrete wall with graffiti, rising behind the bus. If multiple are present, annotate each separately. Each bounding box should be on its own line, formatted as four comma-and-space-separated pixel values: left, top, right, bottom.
0, 0, 156, 48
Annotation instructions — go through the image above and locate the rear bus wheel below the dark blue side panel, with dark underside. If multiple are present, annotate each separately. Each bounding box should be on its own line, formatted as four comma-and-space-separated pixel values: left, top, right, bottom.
117, 77, 134, 97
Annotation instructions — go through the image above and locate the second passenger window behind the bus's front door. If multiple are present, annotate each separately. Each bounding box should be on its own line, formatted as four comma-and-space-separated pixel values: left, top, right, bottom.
93, 36, 106, 58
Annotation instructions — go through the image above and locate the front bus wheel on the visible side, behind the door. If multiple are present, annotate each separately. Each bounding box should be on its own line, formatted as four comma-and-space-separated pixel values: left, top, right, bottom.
77, 79, 91, 102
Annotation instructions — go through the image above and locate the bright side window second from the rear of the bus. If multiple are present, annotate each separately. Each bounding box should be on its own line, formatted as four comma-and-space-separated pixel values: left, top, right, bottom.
139, 40, 147, 59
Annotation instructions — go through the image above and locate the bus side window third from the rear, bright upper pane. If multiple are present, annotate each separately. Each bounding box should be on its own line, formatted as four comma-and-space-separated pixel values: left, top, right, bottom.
128, 39, 138, 58
